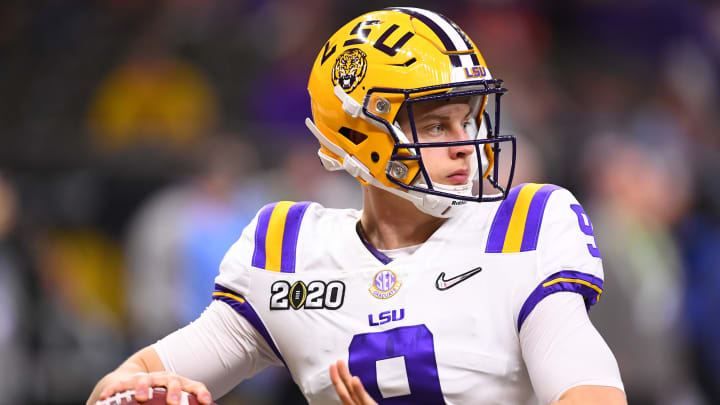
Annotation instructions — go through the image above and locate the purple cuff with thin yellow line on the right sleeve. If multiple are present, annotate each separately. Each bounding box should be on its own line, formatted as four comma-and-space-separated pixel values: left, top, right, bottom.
518, 270, 603, 332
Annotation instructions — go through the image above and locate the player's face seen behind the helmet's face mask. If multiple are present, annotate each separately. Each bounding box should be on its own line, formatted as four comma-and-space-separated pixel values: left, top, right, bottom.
398, 98, 475, 186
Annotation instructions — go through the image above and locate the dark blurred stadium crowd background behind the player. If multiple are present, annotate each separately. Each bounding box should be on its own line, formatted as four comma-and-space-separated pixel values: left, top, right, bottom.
0, 0, 720, 405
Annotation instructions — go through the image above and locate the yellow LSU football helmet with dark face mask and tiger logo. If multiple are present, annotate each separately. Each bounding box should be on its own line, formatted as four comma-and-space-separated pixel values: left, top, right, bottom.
305, 7, 515, 217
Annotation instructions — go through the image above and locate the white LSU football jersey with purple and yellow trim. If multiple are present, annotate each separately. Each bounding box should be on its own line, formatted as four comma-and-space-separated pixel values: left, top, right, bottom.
213, 184, 602, 404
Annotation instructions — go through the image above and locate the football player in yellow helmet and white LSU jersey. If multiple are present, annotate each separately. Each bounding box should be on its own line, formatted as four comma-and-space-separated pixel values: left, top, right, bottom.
89, 8, 626, 405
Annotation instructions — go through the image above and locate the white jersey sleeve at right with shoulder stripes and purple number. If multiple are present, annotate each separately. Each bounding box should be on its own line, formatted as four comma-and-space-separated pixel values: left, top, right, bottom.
486, 183, 603, 331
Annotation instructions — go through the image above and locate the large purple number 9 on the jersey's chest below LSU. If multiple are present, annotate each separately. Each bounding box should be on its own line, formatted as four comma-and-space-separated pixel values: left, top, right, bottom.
348, 325, 445, 405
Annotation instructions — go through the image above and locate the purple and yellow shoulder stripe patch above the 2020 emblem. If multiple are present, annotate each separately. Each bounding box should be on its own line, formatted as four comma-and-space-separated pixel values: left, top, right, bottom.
252, 201, 311, 273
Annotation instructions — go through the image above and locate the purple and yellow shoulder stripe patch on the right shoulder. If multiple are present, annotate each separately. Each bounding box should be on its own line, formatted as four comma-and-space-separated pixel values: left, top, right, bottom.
485, 183, 563, 253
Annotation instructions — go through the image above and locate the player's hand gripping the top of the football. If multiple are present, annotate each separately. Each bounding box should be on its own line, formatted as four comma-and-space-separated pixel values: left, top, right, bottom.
100, 371, 212, 405
